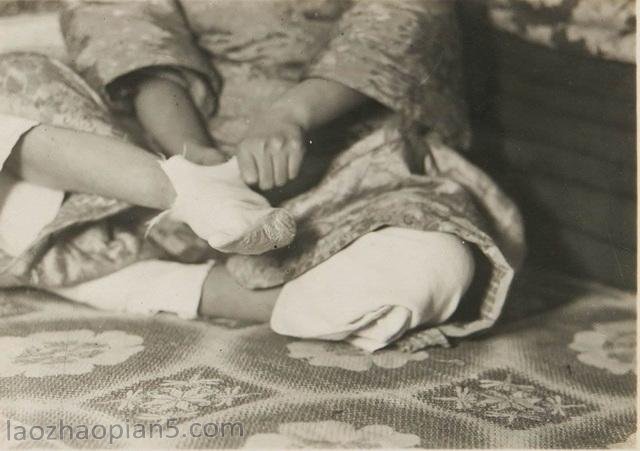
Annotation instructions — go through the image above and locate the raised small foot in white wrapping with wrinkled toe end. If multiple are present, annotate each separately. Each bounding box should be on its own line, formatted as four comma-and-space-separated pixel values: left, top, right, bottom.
160, 156, 296, 255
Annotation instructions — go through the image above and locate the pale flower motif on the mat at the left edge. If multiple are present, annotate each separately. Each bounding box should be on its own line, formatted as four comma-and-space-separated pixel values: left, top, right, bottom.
0, 329, 144, 377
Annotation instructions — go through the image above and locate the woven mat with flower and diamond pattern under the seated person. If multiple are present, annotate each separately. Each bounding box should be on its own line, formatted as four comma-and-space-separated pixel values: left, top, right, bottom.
0, 273, 636, 449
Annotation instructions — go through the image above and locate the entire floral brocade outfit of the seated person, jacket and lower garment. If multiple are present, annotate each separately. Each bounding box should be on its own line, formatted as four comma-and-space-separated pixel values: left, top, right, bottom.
0, 0, 524, 350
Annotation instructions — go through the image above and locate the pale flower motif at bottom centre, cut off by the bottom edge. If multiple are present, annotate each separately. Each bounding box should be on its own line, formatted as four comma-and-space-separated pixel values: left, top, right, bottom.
245, 421, 420, 449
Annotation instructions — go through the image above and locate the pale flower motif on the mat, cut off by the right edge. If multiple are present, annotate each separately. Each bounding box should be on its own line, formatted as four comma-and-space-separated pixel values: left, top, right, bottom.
569, 320, 637, 374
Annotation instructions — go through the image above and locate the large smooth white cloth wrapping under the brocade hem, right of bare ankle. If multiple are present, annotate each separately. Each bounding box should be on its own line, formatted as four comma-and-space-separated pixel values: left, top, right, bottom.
271, 227, 475, 352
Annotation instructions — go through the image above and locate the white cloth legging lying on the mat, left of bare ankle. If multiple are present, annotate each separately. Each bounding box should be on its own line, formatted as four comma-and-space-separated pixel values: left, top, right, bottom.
52, 260, 214, 319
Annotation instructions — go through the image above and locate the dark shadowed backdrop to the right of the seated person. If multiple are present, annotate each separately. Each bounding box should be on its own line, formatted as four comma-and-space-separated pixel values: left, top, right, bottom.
458, 0, 637, 288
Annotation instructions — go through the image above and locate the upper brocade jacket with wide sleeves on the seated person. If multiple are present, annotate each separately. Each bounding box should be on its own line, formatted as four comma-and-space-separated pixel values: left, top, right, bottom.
61, 0, 469, 146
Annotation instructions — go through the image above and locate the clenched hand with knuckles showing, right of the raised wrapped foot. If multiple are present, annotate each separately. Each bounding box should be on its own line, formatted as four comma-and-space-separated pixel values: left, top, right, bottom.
237, 108, 306, 191
